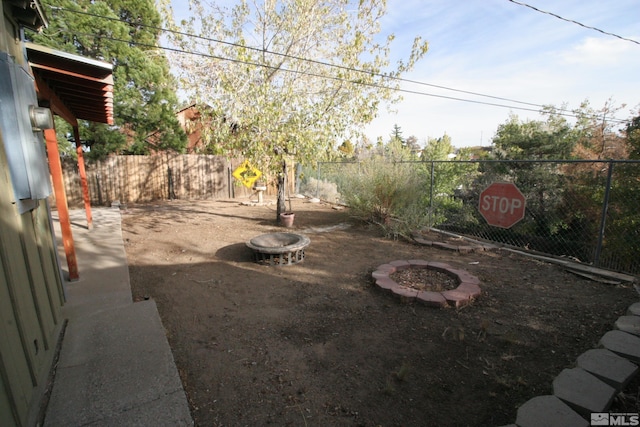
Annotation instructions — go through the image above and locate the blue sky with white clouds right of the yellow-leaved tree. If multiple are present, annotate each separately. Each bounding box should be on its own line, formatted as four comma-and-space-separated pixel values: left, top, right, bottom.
166, 0, 640, 147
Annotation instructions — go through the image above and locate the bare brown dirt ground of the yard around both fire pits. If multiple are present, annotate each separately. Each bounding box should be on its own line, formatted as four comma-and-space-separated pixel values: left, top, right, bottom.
122, 199, 638, 427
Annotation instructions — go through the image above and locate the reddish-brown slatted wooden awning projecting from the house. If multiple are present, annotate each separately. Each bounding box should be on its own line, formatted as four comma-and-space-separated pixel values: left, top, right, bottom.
25, 43, 113, 126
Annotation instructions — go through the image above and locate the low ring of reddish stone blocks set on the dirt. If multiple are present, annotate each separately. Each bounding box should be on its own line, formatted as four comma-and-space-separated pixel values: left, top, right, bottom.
371, 259, 482, 308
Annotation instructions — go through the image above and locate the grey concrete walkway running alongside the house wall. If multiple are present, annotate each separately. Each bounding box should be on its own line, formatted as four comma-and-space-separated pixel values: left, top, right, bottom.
44, 208, 193, 427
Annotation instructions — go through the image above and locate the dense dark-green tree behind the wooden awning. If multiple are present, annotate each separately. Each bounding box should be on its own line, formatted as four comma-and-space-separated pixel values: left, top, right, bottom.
32, 0, 186, 157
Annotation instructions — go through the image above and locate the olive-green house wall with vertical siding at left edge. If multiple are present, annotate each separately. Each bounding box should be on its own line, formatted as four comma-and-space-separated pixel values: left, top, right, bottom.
0, 0, 64, 426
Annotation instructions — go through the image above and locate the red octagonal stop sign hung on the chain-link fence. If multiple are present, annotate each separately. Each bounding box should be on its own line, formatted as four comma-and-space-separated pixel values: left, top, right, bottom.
478, 182, 526, 228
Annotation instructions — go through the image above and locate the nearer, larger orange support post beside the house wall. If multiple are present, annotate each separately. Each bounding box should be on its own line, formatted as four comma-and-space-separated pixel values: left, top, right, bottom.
44, 129, 79, 281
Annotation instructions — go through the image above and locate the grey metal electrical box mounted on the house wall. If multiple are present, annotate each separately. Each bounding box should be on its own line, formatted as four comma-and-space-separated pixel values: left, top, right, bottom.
0, 52, 53, 213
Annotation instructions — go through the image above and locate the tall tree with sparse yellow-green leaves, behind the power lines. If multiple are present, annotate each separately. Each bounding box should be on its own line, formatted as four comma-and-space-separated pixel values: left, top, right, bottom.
165, 0, 427, 217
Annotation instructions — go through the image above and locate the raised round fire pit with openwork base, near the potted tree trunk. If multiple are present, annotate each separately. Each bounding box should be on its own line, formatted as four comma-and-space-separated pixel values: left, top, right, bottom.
247, 233, 311, 265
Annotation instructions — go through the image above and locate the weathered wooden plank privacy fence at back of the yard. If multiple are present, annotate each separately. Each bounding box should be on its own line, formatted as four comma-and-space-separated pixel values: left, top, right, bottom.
58, 154, 293, 207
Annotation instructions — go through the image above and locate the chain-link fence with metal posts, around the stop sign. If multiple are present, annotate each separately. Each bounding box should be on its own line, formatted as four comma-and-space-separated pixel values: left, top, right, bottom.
314, 160, 640, 274
